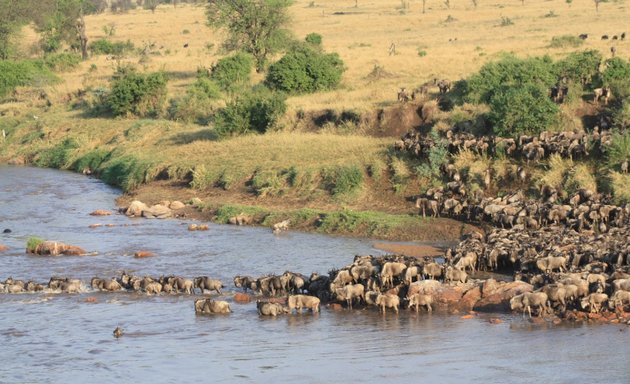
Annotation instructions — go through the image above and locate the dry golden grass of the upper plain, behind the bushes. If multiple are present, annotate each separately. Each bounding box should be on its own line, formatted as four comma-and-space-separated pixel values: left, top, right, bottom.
18, 0, 630, 114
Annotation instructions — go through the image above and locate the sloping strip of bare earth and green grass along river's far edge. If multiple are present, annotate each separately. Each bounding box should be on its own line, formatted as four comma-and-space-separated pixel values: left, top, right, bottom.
116, 178, 481, 244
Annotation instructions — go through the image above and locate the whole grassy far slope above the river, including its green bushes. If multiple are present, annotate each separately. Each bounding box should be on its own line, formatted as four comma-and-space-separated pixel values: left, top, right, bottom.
0, 0, 630, 238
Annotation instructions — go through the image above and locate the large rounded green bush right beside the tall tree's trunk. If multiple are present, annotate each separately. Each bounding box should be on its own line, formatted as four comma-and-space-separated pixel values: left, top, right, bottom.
265, 45, 345, 93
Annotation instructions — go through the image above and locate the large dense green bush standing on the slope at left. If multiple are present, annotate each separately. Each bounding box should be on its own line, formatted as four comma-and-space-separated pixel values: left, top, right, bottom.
107, 71, 167, 117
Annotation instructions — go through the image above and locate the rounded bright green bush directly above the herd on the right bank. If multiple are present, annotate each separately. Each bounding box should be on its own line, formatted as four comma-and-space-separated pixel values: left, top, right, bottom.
488, 84, 559, 137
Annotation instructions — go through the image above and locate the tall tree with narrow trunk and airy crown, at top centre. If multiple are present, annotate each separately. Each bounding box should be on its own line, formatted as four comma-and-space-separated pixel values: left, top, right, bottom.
206, 0, 292, 72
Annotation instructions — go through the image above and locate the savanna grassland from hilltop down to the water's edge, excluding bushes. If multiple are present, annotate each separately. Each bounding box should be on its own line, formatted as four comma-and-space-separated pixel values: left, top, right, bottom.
0, 0, 630, 239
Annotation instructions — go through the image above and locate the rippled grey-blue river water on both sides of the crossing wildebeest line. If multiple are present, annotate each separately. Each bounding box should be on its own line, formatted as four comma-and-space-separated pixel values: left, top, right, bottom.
0, 166, 630, 383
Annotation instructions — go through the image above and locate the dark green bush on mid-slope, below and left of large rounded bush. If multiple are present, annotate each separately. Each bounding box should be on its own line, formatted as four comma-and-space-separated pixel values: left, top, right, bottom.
214, 88, 287, 137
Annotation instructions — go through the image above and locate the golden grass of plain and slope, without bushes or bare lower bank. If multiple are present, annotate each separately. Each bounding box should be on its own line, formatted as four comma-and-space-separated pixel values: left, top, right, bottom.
0, 0, 630, 238
